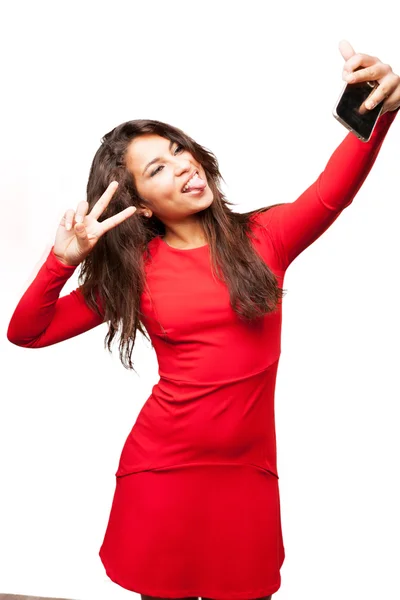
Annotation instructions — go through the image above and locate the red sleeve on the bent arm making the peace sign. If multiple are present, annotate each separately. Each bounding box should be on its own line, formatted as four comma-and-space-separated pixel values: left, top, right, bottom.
7, 247, 103, 348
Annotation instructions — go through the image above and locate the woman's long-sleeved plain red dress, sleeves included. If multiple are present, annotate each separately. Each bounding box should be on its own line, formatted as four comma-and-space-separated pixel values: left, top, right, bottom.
8, 111, 397, 600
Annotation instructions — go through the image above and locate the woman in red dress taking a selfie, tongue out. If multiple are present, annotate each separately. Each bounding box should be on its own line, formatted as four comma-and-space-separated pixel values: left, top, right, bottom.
8, 42, 400, 600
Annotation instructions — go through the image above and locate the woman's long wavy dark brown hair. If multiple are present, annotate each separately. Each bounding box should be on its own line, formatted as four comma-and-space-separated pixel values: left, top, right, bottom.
79, 119, 286, 370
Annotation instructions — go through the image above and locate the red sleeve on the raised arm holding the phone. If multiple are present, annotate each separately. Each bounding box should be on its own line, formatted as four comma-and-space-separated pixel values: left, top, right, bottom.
254, 109, 399, 270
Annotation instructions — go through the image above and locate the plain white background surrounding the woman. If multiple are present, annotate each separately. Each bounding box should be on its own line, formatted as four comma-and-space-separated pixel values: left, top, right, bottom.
0, 0, 400, 600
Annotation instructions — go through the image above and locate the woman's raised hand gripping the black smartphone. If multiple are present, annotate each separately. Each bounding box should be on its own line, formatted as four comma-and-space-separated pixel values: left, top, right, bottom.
339, 40, 400, 115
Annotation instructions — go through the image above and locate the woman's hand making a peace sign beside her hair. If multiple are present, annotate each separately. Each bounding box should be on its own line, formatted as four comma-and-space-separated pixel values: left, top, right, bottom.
53, 181, 136, 266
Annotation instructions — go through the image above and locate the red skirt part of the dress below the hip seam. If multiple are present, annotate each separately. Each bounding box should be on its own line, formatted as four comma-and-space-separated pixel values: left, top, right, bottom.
99, 463, 284, 600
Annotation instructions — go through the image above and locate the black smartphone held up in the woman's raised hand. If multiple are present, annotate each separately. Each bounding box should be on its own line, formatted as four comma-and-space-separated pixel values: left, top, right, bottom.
332, 67, 384, 142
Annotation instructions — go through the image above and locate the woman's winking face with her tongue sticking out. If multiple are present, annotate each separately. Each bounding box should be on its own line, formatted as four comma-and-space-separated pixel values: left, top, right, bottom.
126, 134, 214, 223
